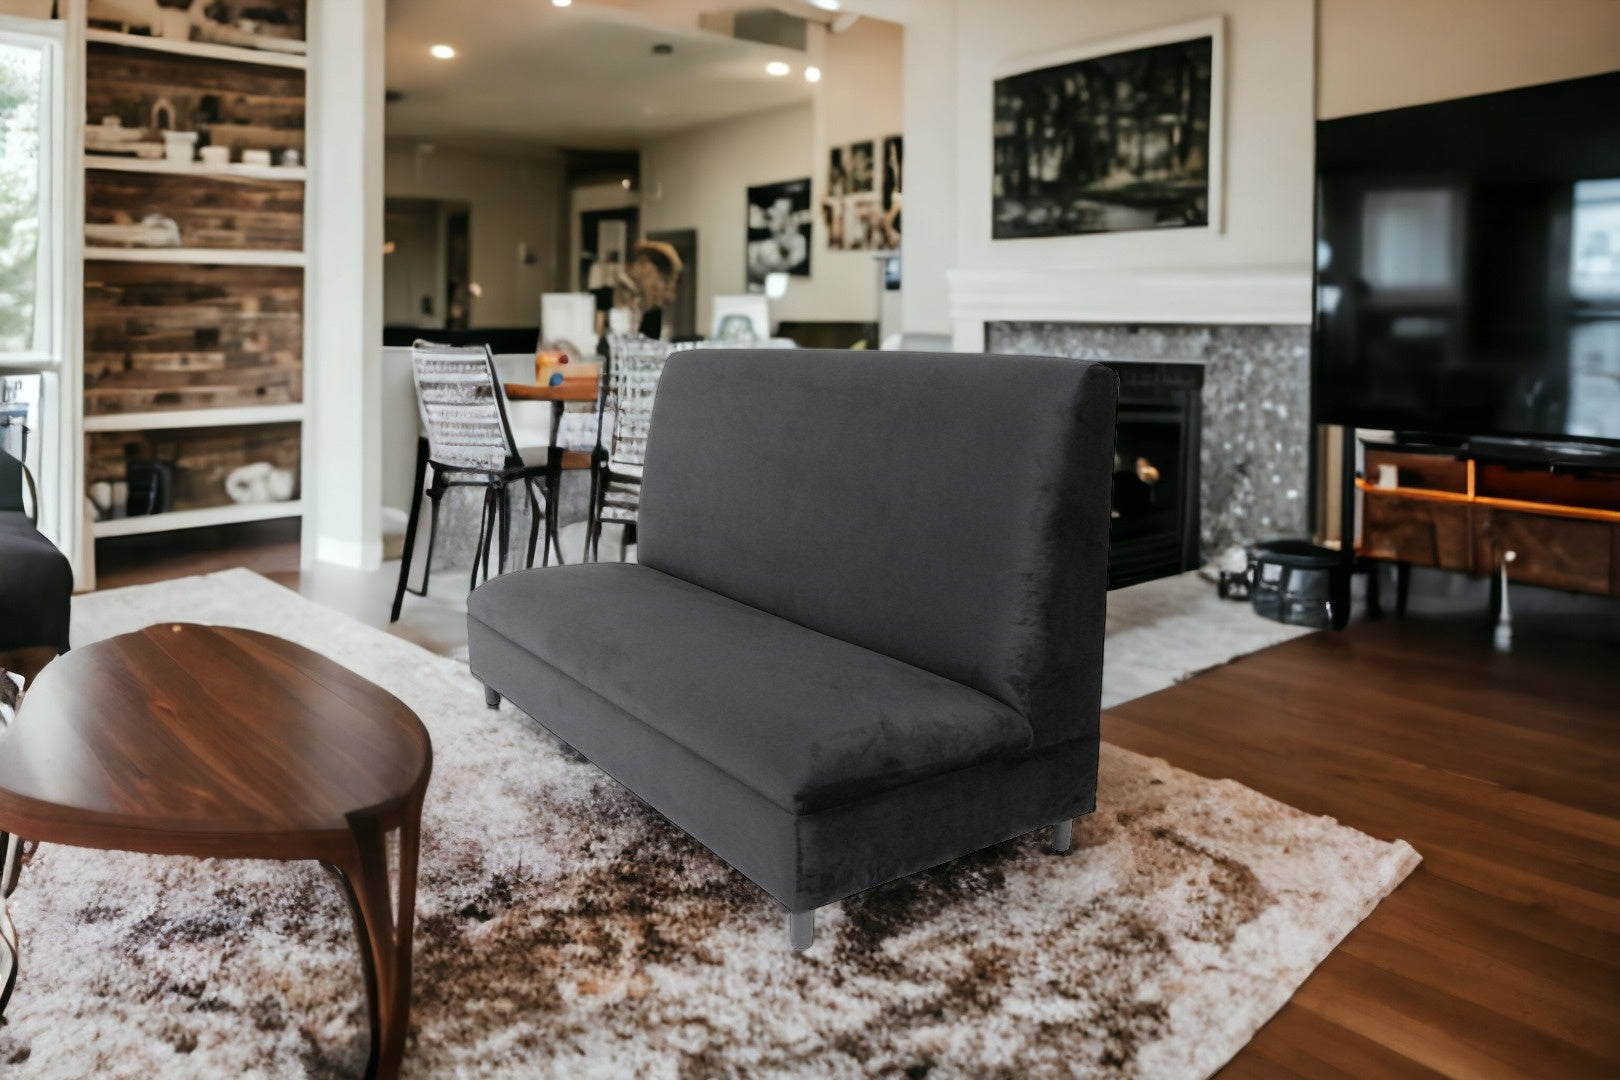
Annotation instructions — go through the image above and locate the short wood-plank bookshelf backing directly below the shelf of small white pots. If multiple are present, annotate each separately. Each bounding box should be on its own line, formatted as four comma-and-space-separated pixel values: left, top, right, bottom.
84, 168, 303, 251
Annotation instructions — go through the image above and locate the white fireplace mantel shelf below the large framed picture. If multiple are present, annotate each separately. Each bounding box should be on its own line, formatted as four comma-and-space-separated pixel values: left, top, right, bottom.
948, 267, 1311, 353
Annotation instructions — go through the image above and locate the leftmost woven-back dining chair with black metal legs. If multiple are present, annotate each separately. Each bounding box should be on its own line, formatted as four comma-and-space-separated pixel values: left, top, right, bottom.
389, 342, 562, 622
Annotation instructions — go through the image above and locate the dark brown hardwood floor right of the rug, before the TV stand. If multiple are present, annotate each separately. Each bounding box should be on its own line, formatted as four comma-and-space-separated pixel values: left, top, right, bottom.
1103, 619, 1620, 1080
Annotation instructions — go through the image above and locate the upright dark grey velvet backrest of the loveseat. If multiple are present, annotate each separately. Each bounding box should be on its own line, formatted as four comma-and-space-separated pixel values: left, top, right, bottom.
638, 350, 1118, 745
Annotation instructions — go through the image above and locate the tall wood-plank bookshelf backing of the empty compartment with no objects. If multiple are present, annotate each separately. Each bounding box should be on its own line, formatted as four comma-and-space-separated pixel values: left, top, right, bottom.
84, 262, 303, 416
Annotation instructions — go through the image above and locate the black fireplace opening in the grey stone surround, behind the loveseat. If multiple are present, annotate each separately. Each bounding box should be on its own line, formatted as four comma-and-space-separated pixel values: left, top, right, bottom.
1108, 361, 1204, 589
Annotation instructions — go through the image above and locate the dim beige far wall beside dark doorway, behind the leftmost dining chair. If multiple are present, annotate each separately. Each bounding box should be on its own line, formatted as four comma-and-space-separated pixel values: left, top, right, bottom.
384, 141, 567, 327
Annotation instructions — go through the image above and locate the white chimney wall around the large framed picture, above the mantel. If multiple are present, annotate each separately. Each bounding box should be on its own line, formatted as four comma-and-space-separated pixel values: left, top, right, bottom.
887, 0, 1315, 334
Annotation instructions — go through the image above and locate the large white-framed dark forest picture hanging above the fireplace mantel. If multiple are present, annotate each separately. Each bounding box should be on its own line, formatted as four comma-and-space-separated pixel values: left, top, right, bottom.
991, 18, 1225, 240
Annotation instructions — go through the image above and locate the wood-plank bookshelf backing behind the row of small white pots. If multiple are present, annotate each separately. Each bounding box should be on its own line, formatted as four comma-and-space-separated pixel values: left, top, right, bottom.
84, 42, 305, 160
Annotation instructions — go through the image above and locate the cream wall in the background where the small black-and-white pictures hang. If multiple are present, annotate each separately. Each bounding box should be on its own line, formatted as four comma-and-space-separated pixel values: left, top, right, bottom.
642, 19, 912, 330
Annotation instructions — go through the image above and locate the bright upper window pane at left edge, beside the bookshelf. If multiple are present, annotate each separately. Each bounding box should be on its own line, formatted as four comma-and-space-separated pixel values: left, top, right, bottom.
0, 19, 62, 364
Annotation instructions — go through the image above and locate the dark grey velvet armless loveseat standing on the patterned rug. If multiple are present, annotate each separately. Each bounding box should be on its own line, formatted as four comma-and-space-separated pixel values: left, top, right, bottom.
468, 350, 1118, 949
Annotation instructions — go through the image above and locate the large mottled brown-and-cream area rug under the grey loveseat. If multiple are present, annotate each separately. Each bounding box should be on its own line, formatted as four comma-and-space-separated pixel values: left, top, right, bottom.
0, 572, 1418, 1080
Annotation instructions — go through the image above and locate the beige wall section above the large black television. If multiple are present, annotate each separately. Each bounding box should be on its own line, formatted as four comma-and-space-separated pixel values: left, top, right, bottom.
1319, 0, 1620, 118
